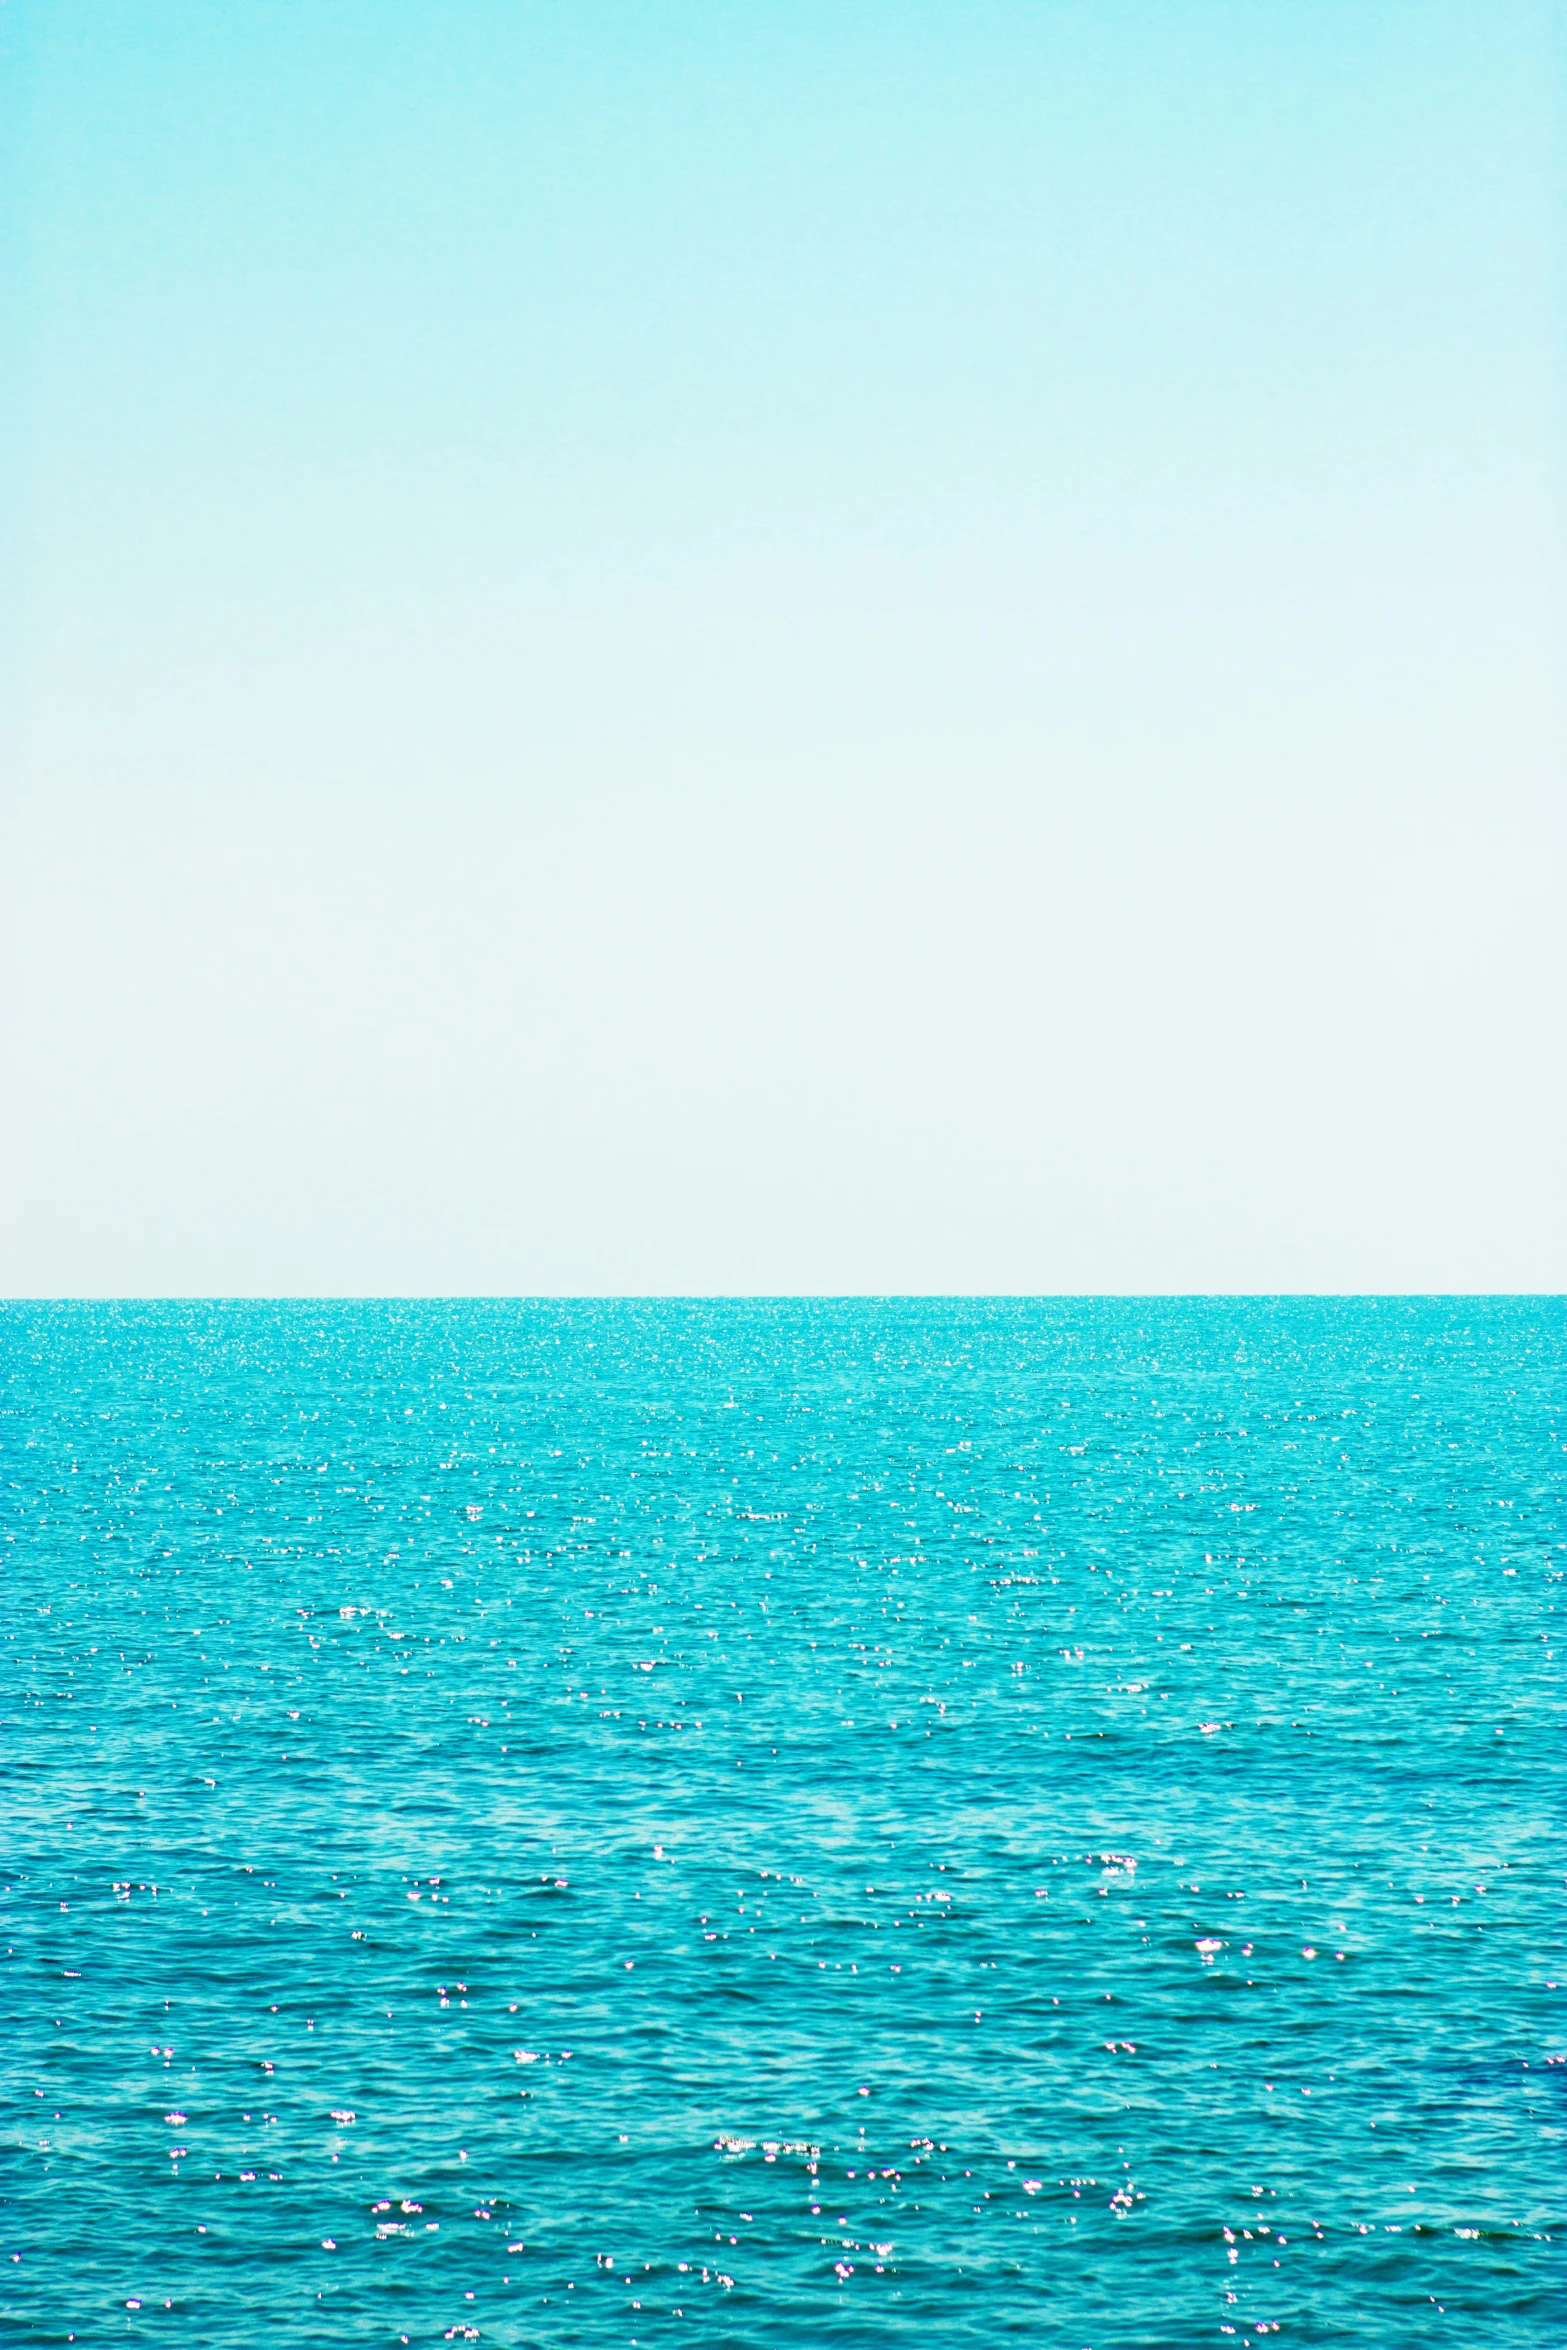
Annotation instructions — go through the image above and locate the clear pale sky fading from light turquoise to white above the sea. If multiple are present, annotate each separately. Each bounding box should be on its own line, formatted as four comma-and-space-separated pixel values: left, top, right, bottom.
0, 0, 1567, 1295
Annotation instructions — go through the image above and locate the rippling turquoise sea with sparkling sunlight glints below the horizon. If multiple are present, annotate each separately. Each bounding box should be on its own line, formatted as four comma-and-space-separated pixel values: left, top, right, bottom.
0, 1300, 1567, 2350
